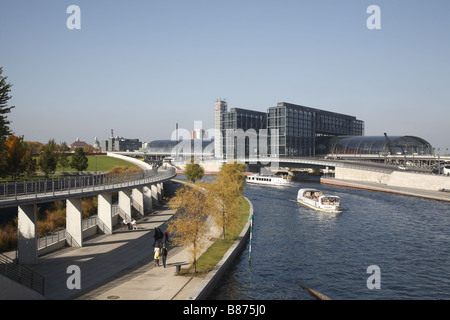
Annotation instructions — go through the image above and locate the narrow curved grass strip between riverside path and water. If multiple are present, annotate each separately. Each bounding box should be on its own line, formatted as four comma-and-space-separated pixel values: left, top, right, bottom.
192, 198, 250, 274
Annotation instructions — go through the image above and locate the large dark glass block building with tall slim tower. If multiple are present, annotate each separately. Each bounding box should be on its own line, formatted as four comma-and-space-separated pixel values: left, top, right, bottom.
215, 100, 364, 158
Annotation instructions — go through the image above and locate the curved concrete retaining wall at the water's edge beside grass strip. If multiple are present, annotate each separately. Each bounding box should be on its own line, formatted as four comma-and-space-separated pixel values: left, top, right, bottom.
189, 198, 253, 300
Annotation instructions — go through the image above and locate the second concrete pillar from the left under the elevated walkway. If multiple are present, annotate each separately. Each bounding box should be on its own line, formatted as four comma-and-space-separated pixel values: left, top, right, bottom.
66, 198, 83, 247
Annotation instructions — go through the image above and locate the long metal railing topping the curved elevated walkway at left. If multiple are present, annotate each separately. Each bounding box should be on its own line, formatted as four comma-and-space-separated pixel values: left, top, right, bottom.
0, 168, 176, 202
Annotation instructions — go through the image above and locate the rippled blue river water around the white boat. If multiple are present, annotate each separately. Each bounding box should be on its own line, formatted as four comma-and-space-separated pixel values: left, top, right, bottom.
212, 182, 450, 300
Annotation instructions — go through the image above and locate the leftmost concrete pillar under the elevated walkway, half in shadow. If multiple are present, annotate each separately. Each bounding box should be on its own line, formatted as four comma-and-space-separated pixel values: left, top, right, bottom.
17, 204, 38, 264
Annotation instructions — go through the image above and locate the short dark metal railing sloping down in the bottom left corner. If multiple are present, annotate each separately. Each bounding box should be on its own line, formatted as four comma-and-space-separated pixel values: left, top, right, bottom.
0, 253, 45, 295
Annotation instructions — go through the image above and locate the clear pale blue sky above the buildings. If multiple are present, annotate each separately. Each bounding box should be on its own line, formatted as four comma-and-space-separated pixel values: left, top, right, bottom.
0, 0, 450, 149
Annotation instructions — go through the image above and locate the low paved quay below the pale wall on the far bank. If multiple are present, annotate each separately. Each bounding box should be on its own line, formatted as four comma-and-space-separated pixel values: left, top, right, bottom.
320, 178, 450, 202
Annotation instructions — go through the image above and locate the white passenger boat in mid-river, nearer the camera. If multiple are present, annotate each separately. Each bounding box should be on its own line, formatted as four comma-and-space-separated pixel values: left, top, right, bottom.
297, 189, 343, 213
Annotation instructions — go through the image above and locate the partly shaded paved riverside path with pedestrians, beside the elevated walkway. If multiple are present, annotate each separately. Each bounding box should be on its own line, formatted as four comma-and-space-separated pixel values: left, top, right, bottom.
27, 202, 220, 300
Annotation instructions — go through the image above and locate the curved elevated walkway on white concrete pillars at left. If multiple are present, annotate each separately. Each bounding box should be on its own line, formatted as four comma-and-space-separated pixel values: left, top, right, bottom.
0, 156, 176, 264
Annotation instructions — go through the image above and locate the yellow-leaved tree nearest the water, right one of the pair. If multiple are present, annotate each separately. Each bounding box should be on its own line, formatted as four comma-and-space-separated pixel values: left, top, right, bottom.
207, 163, 245, 240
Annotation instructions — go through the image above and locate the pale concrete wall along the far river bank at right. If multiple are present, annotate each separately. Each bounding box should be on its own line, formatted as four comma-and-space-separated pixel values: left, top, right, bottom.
335, 167, 450, 191
